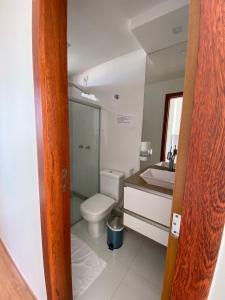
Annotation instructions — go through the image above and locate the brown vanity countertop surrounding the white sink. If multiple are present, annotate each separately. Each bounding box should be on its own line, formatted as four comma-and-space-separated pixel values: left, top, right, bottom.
124, 165, 173, 197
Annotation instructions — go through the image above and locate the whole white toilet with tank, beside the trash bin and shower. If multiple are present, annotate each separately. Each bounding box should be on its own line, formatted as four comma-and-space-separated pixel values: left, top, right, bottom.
80, 170, 124, 238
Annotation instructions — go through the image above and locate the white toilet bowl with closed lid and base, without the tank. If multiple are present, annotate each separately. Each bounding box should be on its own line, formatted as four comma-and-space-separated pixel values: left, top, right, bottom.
80, 194, 116, 238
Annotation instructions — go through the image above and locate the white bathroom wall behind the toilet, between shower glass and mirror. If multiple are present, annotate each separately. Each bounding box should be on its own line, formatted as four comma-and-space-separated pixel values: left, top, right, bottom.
70, 50, 146, 175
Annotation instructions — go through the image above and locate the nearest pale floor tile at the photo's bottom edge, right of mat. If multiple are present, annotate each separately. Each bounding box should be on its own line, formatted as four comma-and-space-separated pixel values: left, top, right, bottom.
111, 271, 160, 300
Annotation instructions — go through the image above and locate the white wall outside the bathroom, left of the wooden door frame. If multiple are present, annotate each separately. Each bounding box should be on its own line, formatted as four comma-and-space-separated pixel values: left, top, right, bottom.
0, 0, 47, 300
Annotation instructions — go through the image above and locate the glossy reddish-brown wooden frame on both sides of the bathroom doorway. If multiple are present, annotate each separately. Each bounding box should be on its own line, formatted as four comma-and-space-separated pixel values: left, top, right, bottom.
32, 0, 225, 300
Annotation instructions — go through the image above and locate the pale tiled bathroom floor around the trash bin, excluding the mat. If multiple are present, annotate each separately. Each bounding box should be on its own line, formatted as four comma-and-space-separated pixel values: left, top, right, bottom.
71, 220, 166, 300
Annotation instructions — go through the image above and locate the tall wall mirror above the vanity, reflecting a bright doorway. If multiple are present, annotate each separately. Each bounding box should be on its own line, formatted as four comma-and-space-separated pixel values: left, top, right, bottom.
140, 42, 187, 169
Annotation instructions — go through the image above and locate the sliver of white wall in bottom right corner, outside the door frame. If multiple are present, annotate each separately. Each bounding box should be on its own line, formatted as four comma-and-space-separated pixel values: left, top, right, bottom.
209, 229, 225, 300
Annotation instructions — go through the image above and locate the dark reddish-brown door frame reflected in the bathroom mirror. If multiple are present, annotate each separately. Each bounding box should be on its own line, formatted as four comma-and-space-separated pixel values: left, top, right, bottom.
160, 92, 183, 161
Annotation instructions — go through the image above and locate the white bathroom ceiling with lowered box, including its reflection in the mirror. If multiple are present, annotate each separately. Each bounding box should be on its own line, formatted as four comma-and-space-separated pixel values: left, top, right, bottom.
68, 0, 188, 84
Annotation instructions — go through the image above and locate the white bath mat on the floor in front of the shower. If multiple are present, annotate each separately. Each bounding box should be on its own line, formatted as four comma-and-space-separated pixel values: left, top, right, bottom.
71, 234, 106, 299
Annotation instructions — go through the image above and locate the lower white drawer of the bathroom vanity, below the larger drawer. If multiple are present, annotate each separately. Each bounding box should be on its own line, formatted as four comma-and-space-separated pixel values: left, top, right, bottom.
123, 213, 169, 247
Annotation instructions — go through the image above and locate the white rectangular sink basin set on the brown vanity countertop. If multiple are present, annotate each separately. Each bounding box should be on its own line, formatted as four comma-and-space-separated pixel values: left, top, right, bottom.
140, 168, 175, 189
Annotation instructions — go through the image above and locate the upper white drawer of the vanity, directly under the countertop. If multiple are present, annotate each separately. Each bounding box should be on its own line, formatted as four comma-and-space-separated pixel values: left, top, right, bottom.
124, 187, 172, 227
